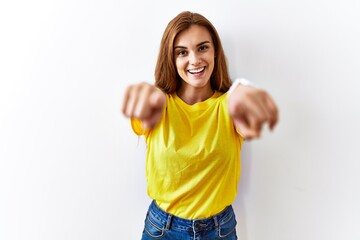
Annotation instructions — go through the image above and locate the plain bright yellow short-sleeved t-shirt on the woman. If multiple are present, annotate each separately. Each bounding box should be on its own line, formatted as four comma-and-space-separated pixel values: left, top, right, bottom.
131, 92, 242, 219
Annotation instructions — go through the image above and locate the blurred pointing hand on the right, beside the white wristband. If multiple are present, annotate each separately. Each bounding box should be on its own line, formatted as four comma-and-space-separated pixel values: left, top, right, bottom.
228, 85, 279, 140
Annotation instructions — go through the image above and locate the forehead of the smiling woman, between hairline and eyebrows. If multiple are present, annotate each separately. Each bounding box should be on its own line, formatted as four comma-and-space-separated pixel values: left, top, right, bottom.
174, 25, 212, 46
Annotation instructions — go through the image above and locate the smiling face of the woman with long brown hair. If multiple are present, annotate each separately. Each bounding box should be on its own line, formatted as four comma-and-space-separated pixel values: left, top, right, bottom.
174, 25, 215, 90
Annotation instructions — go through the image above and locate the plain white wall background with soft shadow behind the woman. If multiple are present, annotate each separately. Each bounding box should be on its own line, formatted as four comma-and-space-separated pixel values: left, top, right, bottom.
0, 0, 360, 240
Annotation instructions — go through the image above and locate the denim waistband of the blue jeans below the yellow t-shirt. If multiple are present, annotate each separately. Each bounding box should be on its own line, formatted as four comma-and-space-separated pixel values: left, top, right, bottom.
148, 201, 234, 232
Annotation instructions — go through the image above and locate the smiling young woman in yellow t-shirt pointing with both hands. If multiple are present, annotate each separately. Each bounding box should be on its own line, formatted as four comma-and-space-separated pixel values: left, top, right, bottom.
123, 12, 278, 240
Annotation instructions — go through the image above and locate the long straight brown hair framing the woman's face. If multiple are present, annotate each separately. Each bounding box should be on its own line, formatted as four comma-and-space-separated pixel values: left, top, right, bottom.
155, 11, 231, 93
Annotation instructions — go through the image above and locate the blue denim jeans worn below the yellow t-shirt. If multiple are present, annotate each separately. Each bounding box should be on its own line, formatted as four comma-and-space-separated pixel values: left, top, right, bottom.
141, 201, 237, 240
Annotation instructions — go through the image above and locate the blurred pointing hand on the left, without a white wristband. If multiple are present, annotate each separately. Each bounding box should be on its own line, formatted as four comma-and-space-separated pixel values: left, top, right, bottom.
122, 83, 166, 129
